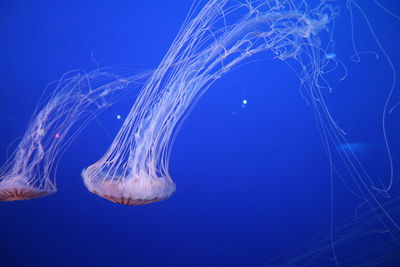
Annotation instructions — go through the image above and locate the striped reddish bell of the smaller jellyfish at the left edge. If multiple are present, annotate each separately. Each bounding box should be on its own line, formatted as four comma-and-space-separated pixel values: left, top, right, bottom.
0, 175, 56, 201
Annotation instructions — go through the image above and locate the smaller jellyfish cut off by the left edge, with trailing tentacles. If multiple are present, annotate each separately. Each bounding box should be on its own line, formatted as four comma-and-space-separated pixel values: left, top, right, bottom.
0, 70, 147, 201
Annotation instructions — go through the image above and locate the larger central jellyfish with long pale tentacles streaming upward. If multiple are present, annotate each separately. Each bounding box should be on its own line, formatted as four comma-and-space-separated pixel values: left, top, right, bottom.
82, 0, 335, 205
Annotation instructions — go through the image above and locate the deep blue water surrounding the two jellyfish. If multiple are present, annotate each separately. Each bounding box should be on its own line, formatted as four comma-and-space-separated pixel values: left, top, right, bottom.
0, 0, 400, 266
